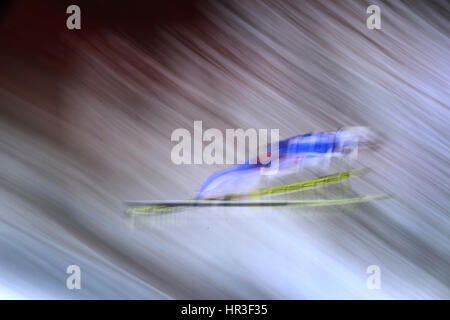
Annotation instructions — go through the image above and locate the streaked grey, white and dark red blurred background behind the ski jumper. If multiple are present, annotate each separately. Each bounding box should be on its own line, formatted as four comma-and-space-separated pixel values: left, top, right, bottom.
0, 0, 450, 299
